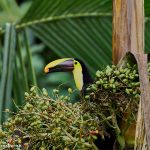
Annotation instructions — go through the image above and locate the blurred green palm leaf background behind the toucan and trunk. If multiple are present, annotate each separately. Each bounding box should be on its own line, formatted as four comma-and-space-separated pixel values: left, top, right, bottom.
0, 0, 150, 123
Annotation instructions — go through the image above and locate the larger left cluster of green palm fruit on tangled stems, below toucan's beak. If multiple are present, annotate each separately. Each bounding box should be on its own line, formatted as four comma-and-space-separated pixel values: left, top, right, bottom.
1, 87, 99, 150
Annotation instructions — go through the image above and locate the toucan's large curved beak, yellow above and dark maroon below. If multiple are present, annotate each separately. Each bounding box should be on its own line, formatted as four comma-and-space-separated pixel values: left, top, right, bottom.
44, 58, 74, 73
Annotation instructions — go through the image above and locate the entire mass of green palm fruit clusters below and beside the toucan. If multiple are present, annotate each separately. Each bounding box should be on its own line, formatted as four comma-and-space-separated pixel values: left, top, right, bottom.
0, 64, 148, 149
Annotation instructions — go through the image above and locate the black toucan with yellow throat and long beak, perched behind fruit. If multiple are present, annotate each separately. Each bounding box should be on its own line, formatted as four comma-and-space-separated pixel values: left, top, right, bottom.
44, 58, 93, 91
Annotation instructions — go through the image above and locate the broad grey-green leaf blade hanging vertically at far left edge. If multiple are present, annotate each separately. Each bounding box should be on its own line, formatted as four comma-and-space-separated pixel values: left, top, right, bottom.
0, 24, 16, 123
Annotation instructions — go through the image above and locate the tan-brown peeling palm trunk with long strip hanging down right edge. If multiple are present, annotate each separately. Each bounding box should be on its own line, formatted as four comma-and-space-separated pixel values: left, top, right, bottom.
113, 0, 150, 149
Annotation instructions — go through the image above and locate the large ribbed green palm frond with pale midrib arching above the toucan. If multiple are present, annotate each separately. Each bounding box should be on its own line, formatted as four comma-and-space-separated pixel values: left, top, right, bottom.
17, 0, 112, 74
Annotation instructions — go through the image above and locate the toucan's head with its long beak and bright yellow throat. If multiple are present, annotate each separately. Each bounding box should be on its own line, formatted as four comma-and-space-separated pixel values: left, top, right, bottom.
44, 58, 84, 90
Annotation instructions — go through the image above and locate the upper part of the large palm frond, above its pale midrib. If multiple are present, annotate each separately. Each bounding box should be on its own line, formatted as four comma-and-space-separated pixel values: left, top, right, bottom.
22, 0, 112, 25
